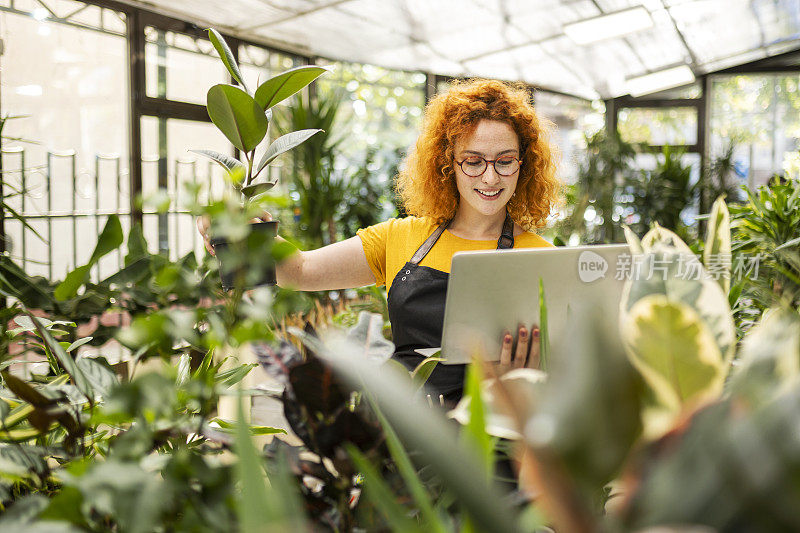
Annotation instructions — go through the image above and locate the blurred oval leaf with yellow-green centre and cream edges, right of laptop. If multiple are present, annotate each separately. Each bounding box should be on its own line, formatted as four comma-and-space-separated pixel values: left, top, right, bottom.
622, 295, 726, 414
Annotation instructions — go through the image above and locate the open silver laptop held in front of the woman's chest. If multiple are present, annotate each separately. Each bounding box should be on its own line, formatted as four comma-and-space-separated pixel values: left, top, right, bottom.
442, 244, 632, 364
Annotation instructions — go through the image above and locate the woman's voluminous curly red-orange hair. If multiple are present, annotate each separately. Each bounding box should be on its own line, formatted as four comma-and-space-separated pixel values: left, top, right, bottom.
395, 79, 561, 230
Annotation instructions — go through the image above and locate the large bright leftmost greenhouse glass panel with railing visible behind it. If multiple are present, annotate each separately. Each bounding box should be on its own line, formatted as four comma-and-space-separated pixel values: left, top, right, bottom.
0, 0, 130, 280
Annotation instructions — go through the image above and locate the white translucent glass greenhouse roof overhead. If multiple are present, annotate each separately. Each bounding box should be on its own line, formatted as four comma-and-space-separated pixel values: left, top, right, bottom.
130, 0, 800, 98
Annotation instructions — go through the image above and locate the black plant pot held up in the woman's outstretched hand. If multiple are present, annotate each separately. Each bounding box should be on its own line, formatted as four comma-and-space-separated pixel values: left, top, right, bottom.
211, 221, 278, 291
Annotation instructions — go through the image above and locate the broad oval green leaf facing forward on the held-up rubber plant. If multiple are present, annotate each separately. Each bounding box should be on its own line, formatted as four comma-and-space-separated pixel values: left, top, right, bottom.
206, 84, 269, 152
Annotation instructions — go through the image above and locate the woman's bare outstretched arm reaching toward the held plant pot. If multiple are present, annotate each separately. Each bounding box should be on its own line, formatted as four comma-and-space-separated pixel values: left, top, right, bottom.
275, 237, 375, 291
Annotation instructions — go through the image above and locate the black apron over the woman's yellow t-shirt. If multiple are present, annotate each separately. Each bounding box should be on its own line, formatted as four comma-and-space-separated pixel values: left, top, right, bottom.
387, 213, 514, 406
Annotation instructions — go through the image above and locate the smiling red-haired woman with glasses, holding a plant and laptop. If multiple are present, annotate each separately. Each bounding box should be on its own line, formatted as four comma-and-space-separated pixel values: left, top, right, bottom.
198, 80, 560, 405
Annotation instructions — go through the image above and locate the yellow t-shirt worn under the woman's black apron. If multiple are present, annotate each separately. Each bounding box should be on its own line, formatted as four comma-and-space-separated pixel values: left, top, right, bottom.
356, 217, 553, 289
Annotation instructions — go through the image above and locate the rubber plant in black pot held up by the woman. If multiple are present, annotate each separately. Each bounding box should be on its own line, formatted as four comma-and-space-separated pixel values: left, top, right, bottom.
192, 29, 327, 290
